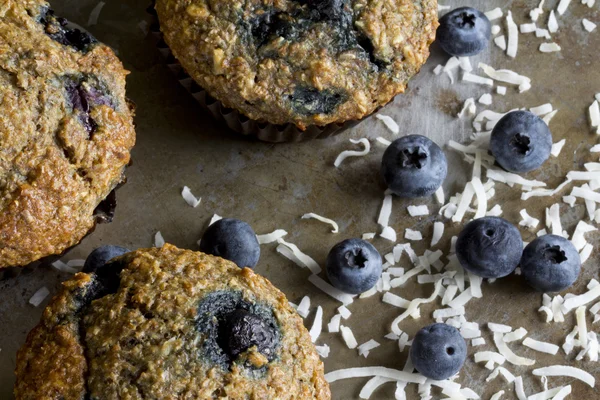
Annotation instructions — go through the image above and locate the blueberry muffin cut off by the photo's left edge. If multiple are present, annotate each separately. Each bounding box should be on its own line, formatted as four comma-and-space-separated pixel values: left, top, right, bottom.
0, 0, 135, 269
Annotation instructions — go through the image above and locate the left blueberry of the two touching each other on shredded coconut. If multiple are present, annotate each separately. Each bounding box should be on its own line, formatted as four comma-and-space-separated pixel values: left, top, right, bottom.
456, 217, 523, 279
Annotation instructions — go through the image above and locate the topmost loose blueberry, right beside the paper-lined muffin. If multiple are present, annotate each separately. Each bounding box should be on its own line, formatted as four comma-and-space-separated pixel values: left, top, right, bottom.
437, 7, 492, 57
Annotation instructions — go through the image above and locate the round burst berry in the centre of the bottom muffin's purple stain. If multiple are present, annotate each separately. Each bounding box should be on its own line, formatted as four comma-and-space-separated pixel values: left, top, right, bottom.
226, 310, 278, 359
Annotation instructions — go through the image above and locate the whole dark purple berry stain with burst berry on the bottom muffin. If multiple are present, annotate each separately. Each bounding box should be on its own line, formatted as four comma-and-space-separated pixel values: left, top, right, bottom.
196, 291, 280, 369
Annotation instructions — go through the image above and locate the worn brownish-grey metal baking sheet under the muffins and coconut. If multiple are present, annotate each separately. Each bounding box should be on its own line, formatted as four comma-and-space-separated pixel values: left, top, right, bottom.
0, 0, 600, 400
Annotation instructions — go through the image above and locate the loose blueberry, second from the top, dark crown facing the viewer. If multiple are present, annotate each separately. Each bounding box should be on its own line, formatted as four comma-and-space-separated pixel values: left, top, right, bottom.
490, 111, 552, 173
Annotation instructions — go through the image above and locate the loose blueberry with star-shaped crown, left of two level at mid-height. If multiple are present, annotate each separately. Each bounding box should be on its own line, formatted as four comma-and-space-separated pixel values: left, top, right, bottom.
381, 135, 448, 198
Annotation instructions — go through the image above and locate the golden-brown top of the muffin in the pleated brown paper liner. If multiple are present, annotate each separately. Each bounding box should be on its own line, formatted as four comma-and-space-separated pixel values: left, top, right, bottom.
156, 0, 438, 129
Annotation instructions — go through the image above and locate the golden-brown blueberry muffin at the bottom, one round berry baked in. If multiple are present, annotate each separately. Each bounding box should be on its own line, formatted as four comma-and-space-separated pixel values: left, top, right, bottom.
15, 244, 331, 400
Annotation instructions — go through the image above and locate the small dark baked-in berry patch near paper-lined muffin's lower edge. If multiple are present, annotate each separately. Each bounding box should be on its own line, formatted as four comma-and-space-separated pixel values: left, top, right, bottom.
289, 86, 346, 116
